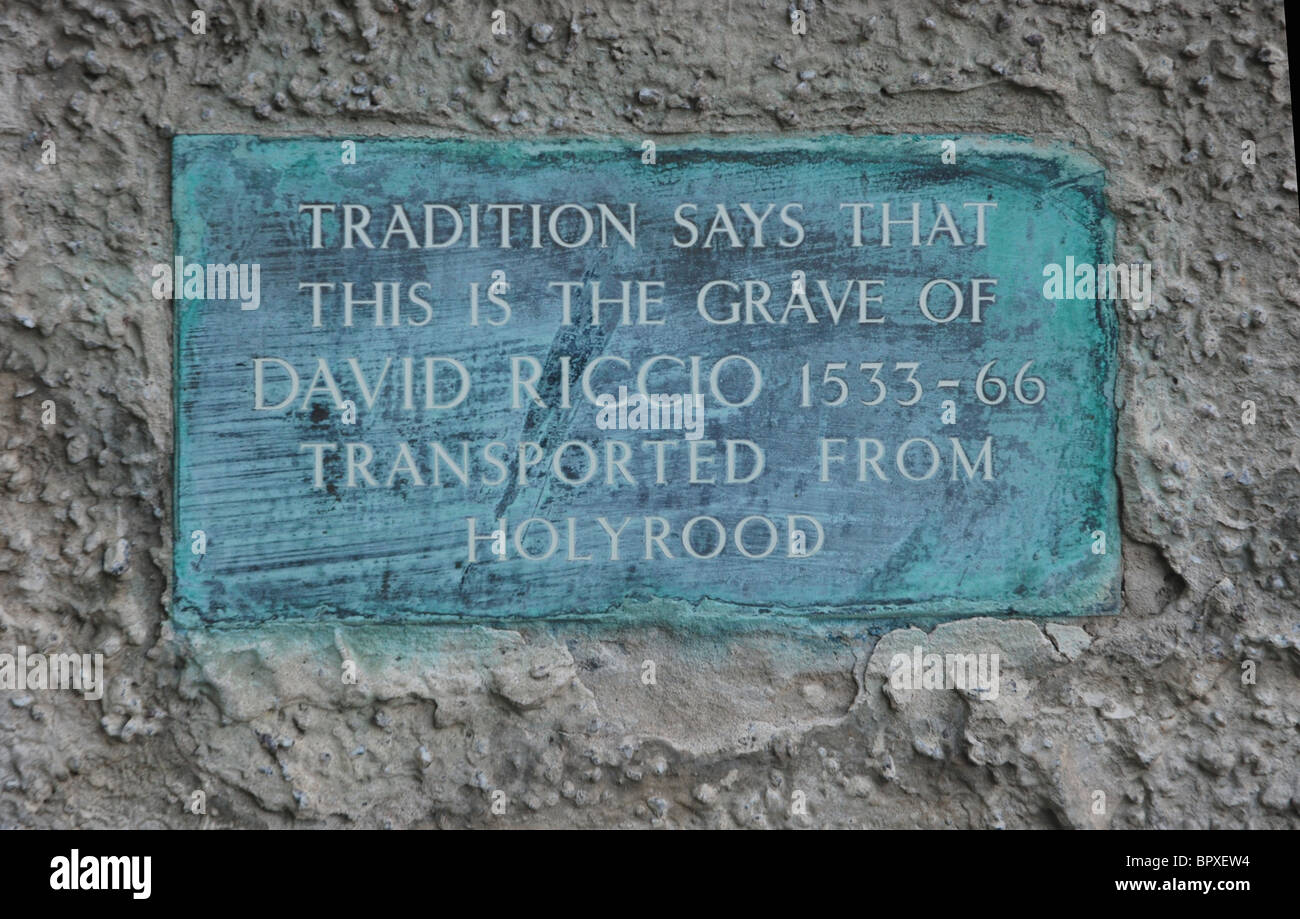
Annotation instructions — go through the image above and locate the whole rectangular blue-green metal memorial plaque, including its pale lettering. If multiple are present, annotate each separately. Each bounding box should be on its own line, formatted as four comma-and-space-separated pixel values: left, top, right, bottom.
172, 135, 1119, 628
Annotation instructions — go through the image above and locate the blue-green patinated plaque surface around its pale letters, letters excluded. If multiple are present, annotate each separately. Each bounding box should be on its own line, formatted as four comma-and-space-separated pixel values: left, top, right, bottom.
173, 135, 1119, 628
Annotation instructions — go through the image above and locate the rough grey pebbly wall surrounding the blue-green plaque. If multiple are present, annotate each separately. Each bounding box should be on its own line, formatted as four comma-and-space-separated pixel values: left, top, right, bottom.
0, 0, 1300, 828
